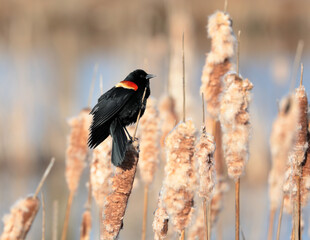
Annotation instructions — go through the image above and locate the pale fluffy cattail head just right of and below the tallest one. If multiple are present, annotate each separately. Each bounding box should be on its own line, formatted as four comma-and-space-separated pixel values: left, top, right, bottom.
220, 74, 253, 180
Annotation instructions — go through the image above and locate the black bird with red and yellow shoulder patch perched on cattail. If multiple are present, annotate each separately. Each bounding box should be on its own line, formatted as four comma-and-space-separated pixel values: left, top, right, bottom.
88, 69, 155, 166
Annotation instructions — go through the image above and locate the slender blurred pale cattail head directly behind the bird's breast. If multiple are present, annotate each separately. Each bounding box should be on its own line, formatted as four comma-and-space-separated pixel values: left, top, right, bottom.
139, 98, 159, 185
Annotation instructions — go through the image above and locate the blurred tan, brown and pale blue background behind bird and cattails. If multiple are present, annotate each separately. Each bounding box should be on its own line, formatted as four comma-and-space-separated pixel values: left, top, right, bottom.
0, 0, 310, 239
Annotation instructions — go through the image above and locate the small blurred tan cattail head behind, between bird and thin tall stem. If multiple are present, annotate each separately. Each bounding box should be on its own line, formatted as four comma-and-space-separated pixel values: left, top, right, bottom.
159, 95, 178, 147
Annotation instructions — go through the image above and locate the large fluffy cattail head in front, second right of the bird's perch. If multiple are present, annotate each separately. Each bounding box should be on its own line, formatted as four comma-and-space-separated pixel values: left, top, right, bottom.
163, 120, 196, 232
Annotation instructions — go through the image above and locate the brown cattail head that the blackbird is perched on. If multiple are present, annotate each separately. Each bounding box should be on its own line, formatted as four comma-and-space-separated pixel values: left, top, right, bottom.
103, 143, 139, 240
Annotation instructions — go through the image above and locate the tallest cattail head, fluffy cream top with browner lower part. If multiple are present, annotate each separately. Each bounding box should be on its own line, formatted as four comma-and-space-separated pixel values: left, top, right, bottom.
200, 11, 236, 119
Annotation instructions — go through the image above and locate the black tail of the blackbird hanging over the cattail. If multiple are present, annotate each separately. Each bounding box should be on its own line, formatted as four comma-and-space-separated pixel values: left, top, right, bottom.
110, 119, 128, 166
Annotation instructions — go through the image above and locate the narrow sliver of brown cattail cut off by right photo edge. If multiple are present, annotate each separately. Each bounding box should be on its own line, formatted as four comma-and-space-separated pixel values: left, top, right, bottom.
300, 123, 310, 206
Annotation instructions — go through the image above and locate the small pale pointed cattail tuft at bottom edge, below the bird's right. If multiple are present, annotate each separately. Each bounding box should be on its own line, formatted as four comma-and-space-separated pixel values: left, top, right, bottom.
153, 193, 169, 240
